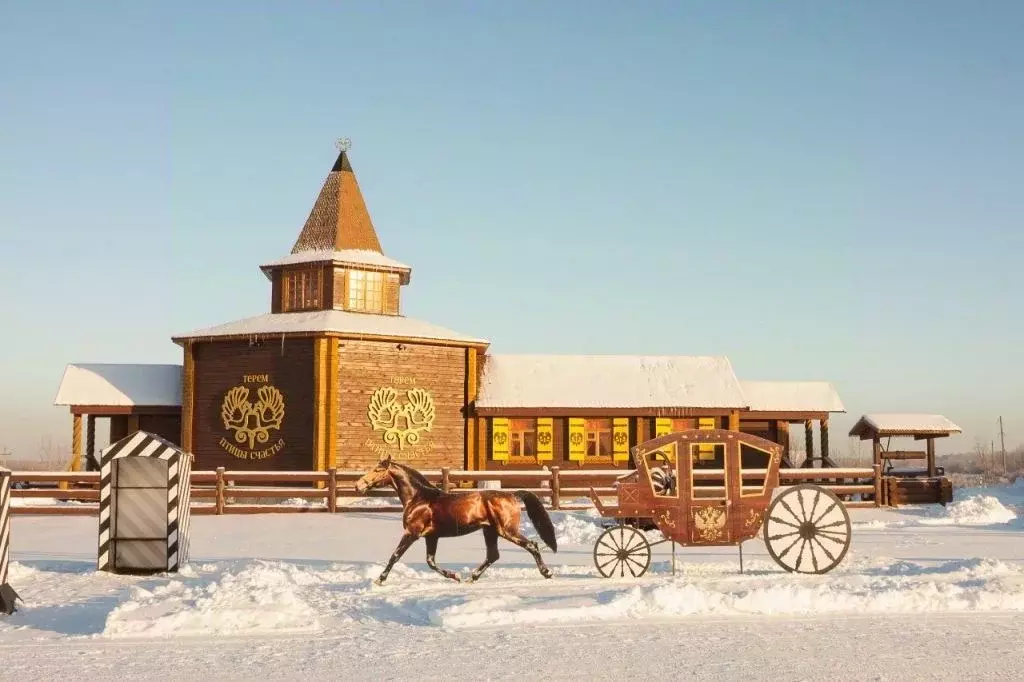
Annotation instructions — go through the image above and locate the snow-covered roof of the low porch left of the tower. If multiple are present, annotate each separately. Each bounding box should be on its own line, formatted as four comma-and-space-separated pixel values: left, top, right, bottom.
53, 364, 181, 407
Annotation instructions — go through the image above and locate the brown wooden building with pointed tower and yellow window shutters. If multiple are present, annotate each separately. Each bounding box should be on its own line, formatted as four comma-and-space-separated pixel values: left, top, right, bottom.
58, 145, 844, 470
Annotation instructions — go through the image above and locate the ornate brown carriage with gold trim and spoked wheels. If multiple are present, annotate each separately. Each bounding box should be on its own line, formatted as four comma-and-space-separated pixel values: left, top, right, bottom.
590, 429, 851, 578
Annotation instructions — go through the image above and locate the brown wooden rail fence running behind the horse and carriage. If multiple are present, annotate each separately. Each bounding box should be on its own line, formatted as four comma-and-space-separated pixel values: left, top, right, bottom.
4, 467, 882, 515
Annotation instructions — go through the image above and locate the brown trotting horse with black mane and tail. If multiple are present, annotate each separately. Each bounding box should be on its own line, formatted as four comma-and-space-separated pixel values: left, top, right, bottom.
355, 455, 558, 585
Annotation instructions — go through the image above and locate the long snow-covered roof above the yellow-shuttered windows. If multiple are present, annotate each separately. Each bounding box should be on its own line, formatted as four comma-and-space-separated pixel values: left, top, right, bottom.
476, 354, 745, 408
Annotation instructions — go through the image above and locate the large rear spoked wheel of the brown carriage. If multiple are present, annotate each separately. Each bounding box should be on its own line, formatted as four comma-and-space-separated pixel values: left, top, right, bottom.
764, 483, 850, 573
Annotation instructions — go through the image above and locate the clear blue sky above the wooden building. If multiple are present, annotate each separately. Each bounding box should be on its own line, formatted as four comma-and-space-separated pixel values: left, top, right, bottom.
0, 0, 1024, 455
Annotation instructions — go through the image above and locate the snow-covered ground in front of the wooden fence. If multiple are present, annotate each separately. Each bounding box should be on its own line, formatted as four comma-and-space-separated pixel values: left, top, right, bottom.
0, 480, 1024, 680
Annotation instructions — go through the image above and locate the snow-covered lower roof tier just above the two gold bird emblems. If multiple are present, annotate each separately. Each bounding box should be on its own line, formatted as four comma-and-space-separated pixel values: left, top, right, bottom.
174, 310, 487, 344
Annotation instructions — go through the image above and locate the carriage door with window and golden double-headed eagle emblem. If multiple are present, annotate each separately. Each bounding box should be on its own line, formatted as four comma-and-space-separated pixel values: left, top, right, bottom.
685, 429, 739, 545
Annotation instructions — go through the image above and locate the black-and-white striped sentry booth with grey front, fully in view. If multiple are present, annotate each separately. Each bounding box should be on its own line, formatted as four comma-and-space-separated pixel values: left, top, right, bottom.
96, 431, 193, 573
